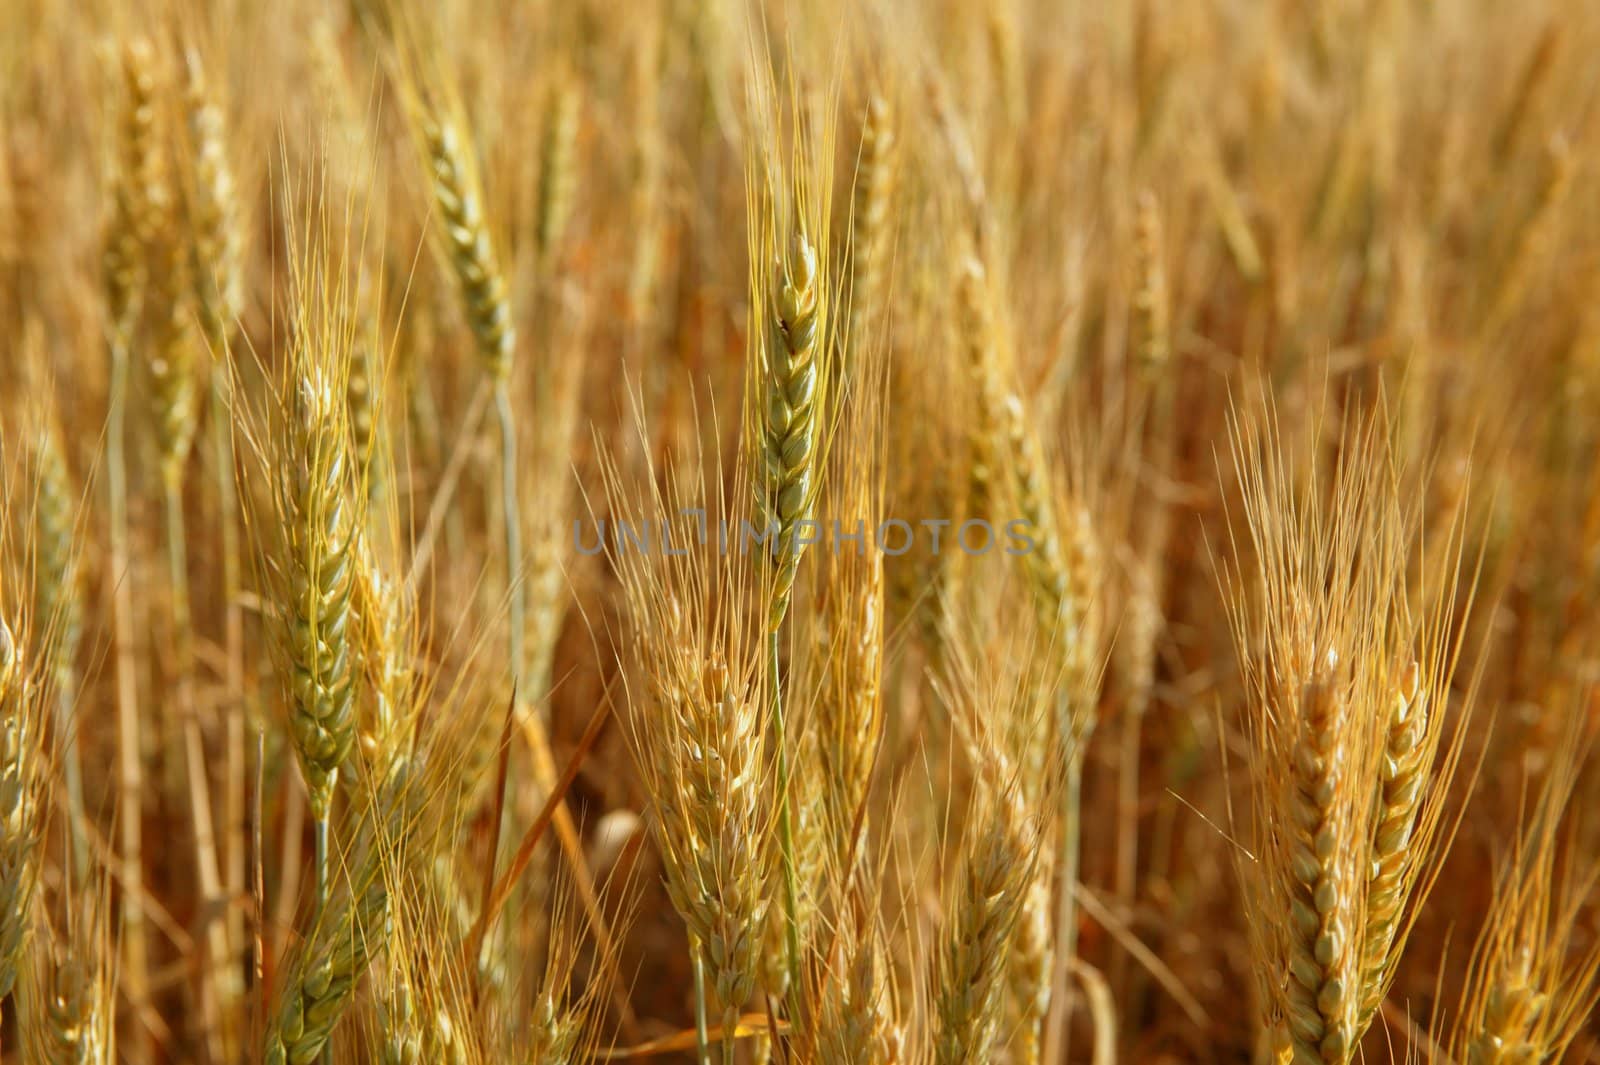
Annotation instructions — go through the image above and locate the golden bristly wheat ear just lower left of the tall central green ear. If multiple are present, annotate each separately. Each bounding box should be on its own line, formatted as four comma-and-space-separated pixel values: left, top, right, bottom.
603, 464, 774, 1065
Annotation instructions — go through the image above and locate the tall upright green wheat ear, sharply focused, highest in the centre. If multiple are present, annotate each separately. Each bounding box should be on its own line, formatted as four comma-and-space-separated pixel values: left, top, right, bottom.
758, 232, 821, 630
